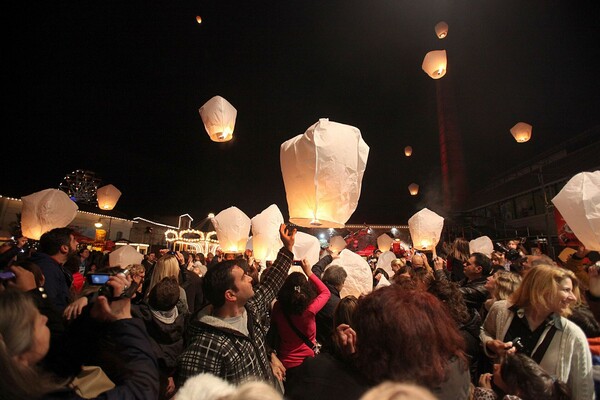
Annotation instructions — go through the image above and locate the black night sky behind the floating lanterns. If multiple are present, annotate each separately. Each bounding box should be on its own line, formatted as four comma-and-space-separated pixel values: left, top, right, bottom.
5, 0, 600, 224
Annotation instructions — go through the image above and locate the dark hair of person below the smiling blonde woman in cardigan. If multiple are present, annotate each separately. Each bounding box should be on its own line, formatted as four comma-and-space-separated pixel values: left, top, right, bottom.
500, 353, 571, 400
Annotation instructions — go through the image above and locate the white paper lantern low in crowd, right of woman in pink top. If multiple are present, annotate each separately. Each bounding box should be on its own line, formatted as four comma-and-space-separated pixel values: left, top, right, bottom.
329, 249, 373, 297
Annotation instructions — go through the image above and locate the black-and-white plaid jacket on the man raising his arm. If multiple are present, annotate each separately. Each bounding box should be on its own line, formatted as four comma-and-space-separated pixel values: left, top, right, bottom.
177, 247, 294, 388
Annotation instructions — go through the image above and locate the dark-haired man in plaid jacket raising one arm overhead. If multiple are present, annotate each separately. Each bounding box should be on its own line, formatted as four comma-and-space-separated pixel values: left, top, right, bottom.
178, 225, 296, 388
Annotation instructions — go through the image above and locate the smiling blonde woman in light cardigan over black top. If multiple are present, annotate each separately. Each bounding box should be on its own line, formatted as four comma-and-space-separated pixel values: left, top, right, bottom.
481, 265, 594, 399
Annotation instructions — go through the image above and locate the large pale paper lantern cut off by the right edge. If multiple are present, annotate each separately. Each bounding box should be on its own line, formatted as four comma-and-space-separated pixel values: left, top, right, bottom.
552, 171, 600, 251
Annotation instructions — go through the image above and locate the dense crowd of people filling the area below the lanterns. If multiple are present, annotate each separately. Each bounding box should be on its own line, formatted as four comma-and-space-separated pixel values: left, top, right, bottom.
0, 225, 600, 400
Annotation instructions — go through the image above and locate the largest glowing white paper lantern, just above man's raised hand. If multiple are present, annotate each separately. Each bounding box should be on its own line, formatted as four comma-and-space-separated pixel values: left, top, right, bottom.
280, 119, 369, 228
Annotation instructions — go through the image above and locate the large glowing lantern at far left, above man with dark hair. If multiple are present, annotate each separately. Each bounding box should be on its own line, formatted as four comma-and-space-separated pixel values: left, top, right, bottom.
21, 189, 79, 240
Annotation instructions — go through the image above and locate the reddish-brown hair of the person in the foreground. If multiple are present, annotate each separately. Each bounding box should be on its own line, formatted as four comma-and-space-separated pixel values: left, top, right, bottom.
354, 285, 468, 387
